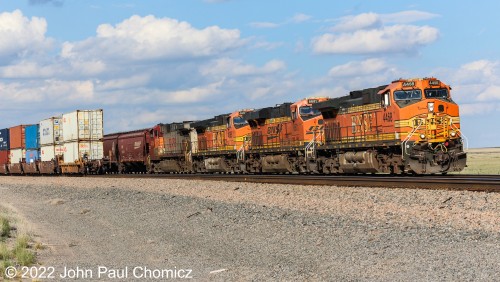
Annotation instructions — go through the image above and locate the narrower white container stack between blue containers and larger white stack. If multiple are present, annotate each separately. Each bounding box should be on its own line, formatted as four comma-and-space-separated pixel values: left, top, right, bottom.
40, 117, 63, 162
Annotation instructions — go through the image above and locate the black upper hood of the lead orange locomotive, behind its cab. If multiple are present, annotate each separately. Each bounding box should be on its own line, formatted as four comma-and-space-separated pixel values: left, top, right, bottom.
313, 85, 387, 112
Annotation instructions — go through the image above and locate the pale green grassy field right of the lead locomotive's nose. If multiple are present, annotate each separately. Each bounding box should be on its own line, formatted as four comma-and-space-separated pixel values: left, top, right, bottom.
461, 148, 500, 174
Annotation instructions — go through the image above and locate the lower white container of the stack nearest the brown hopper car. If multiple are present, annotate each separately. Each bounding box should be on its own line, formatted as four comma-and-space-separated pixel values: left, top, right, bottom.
62, 141, 104, 163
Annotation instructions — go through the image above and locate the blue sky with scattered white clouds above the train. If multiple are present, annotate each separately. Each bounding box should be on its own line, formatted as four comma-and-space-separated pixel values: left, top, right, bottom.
0, 0, 500, 148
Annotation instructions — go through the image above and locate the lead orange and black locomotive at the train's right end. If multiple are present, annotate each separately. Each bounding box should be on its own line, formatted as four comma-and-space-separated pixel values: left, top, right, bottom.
313, 78, 466, 174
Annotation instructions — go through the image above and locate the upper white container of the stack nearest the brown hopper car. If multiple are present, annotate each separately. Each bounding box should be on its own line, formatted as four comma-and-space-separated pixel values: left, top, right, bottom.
62, 110, 103, 142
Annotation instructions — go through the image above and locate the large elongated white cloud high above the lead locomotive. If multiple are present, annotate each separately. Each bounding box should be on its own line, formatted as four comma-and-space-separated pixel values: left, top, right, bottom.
313, 25, 439, 54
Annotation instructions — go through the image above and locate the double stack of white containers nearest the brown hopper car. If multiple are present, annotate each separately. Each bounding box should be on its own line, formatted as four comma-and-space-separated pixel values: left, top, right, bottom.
61, 110, 104, 163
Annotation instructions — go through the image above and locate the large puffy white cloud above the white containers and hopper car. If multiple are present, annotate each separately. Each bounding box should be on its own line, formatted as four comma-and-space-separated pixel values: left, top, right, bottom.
61, 16, 244, 61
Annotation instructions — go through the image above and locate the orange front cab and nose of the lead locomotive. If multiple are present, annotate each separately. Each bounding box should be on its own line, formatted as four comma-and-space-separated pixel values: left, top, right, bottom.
379, 78, 466, 174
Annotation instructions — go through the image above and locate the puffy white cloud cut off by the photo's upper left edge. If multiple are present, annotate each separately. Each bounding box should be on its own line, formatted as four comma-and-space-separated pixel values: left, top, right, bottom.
0, 10, 51, 61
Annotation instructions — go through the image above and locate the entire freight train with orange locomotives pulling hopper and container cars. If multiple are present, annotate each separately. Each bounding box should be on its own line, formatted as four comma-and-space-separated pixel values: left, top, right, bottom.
0, 78, 467, 175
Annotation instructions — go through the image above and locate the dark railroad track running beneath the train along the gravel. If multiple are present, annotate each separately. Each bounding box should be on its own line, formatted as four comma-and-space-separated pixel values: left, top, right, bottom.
90, 174, 500, 192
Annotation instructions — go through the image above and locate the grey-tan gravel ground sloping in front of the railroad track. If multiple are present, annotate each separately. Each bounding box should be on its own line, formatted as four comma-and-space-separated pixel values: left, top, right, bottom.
0, 177, 500, 281
